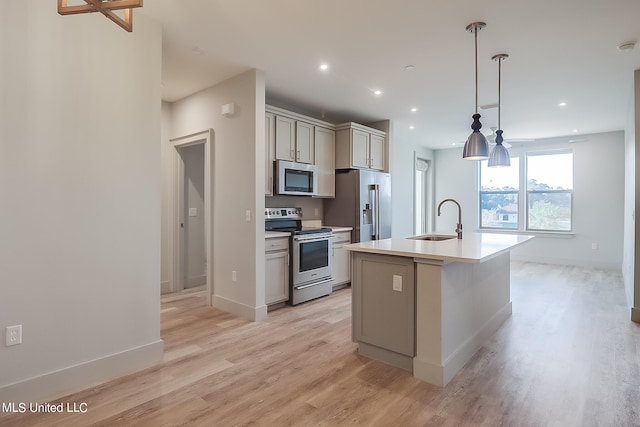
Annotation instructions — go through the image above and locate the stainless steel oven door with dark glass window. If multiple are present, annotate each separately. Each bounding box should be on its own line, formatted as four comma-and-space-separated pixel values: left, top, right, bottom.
293, 234, 332, 287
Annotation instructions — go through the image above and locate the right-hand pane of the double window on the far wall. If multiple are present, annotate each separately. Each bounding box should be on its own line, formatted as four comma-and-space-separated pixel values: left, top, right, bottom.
527, 153, 573, 231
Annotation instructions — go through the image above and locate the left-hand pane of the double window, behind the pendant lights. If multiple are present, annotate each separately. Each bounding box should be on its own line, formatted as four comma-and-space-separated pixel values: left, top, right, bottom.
480, 157, 520, 230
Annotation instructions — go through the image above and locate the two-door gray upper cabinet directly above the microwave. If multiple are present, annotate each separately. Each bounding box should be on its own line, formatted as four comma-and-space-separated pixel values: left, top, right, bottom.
275, 115, 315, 164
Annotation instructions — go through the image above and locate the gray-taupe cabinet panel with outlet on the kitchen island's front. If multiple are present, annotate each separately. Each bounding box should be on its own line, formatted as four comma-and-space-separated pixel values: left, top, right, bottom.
351, 252, 415, 357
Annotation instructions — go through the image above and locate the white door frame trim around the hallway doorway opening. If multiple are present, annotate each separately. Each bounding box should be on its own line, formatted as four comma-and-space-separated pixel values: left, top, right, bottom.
169, 129, 214, 305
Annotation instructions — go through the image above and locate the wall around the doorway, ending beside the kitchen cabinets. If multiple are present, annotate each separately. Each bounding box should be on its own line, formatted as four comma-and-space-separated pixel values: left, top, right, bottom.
162, 70, 266, 320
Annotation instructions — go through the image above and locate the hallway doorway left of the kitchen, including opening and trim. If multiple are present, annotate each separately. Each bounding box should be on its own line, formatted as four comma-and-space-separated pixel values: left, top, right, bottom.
171, 129, 213, 305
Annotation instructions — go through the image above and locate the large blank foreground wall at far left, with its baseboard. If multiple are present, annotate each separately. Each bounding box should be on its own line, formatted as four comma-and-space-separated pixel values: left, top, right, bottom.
0, 0, 163, 402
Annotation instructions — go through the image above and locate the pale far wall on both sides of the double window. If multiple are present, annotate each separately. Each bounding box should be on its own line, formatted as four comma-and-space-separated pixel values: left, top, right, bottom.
435, 132, 624, 270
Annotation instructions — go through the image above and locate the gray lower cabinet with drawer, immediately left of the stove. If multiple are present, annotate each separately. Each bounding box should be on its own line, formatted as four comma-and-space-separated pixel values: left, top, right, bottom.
264, 238, 289, 305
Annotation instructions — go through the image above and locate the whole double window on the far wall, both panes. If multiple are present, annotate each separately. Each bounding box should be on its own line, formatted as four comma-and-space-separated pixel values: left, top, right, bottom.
479, 151, 573, 232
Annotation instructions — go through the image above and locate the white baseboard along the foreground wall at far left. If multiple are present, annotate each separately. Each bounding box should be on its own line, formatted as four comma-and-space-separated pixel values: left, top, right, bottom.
0, 340, 164, 402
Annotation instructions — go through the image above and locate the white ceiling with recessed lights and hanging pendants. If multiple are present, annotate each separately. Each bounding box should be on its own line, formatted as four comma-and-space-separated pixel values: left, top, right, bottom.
139, 0, 640, 148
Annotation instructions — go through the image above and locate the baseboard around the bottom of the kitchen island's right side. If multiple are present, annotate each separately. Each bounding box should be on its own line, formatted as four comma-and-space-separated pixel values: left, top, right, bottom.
413, 301, 512, 387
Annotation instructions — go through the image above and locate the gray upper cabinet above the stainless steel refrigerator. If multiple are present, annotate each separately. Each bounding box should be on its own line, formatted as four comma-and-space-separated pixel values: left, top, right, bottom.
336, 123, 386, 170
